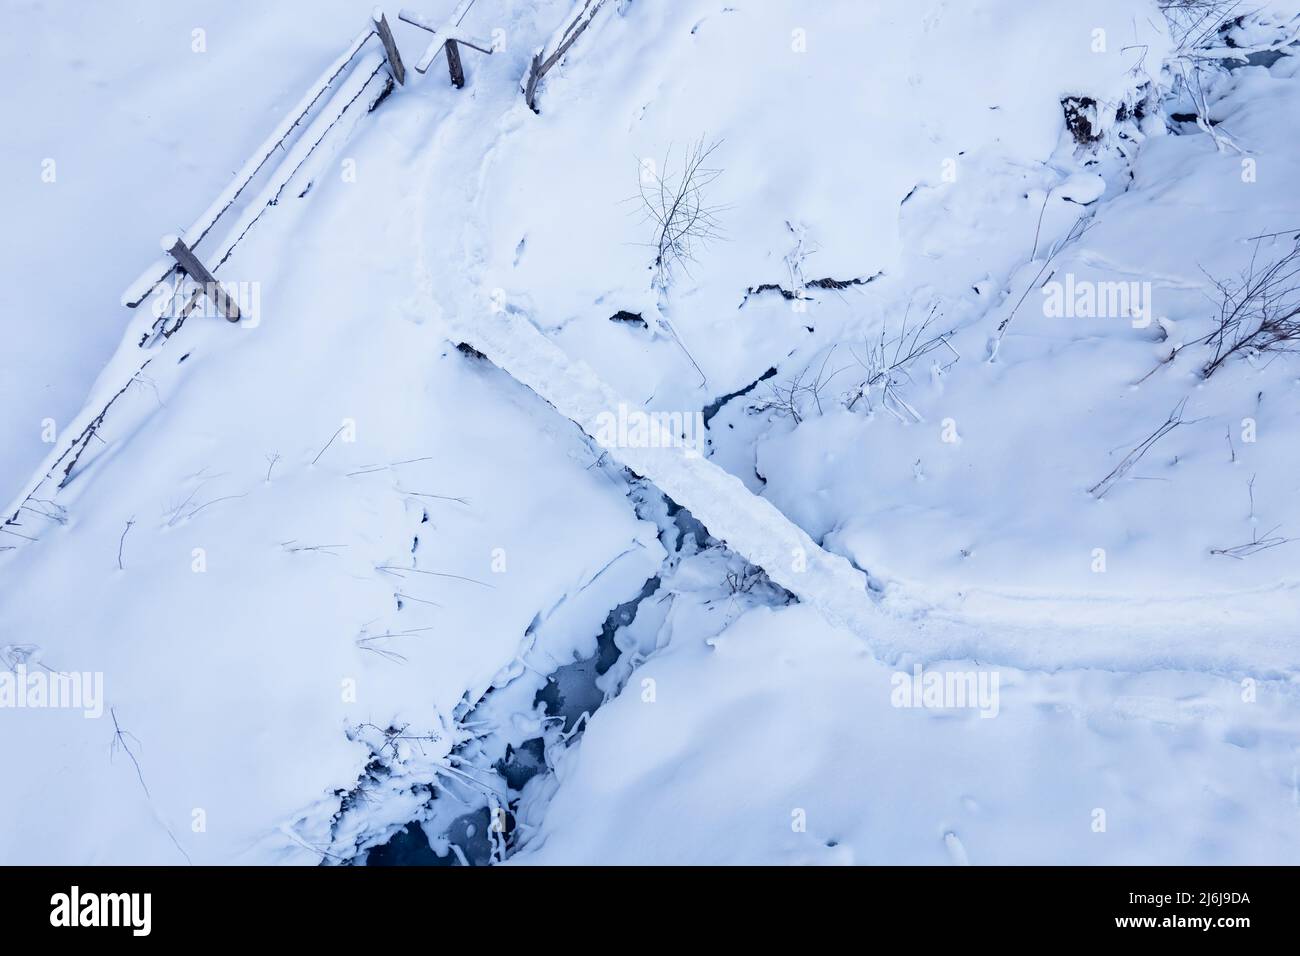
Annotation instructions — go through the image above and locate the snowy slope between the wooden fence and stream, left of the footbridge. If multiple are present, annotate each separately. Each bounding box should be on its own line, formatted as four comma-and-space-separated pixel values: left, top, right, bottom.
0, 0, 660, 862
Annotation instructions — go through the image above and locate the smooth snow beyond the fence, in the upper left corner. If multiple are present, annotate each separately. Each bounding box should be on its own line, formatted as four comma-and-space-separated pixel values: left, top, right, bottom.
0, 0, 390, 502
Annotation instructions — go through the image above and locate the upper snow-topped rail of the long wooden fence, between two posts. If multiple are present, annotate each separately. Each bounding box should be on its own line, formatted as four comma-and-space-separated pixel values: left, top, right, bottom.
122, 9, 406, 308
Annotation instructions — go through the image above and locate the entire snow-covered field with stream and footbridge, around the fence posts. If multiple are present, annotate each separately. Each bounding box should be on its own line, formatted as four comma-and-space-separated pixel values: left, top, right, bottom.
0, 0, 1300, 865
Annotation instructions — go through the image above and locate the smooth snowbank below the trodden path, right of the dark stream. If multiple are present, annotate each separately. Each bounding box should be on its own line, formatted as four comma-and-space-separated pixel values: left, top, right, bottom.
514, 598, 1300, 865
